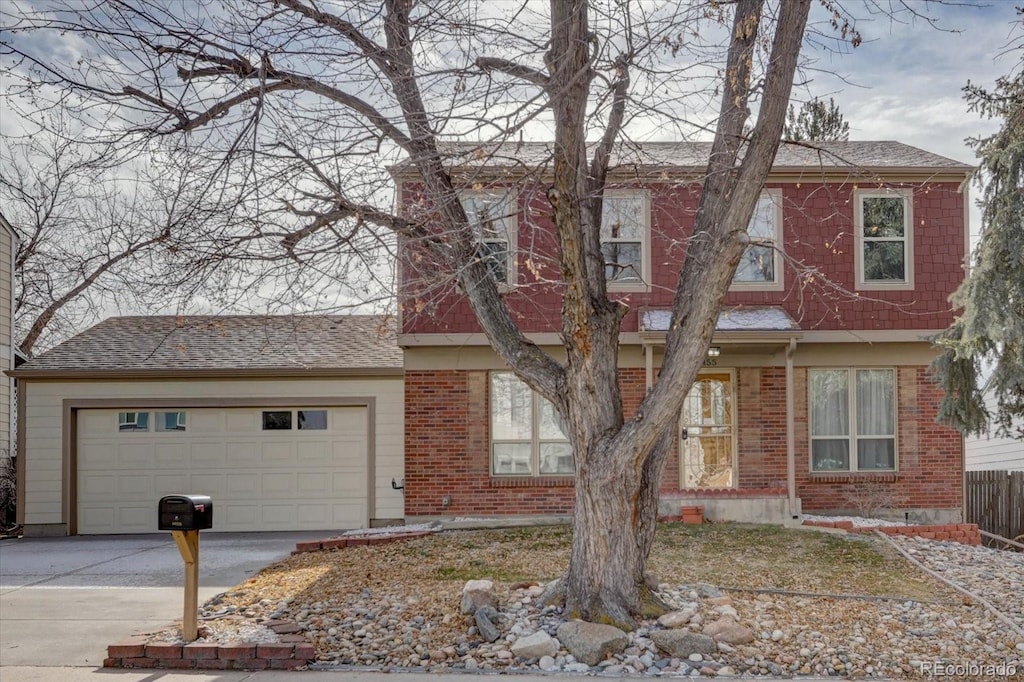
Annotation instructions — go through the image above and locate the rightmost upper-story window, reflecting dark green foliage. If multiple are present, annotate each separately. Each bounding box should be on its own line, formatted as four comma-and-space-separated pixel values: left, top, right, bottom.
854, 189, 913, 289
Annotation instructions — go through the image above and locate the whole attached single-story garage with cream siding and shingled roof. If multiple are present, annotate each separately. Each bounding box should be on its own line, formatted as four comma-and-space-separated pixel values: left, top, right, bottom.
16, 316, 403, 535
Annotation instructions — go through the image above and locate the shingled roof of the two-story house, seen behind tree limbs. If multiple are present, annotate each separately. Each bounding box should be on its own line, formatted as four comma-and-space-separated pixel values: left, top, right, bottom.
392, 140, 973, 175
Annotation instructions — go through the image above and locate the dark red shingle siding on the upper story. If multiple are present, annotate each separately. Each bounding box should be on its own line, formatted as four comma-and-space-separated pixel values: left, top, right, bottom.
400, 182, 964, 334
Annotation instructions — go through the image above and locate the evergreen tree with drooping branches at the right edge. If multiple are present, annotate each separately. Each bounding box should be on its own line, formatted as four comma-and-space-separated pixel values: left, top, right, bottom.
933, 46, 1024, 438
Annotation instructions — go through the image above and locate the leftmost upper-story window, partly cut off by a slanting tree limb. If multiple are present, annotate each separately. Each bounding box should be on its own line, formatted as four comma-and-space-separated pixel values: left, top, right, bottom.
459, 189, 516, 285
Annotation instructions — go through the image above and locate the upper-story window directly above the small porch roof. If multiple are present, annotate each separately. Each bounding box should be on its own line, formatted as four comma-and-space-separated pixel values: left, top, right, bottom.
732, 189, 782, 290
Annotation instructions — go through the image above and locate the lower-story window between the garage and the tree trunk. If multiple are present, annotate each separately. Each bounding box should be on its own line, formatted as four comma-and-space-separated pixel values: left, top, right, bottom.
490, 372, 573, 476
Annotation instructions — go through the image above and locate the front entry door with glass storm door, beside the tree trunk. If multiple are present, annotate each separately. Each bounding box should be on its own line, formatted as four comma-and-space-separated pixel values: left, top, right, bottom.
679, 373, 736, 487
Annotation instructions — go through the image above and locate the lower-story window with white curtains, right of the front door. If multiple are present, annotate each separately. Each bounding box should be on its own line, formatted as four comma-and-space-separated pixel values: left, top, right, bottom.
809, 369, 896, 472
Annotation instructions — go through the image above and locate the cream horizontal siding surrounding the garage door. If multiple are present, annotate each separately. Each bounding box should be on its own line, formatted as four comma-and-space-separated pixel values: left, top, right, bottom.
22, 376, 404, 524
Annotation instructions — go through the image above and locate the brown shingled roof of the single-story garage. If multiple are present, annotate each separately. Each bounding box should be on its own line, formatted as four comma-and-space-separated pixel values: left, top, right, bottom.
12, 315, 402, 378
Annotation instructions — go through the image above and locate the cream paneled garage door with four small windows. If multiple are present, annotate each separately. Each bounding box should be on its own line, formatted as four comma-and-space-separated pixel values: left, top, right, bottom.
78, 407, 369, 534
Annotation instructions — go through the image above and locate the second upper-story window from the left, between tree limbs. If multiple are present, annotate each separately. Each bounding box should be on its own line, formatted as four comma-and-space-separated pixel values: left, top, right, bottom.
601, 189, 650, 291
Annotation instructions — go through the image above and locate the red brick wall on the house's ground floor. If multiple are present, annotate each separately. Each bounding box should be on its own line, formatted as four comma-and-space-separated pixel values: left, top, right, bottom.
406, 367, 963, 516
